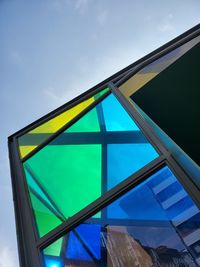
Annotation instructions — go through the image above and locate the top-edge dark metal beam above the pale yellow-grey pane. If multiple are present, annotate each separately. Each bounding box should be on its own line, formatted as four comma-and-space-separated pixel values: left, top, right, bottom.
115, 28, 200, 87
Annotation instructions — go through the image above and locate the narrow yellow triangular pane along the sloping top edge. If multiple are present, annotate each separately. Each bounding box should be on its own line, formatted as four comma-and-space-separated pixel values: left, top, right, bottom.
18, 88, 109, 158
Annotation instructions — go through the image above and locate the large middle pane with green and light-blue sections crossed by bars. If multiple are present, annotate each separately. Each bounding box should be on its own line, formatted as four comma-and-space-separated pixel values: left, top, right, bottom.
24, 94, 158, 238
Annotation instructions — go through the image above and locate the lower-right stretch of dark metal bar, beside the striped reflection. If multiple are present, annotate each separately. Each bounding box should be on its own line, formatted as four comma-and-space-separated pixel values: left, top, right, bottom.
167, 156, 200, 209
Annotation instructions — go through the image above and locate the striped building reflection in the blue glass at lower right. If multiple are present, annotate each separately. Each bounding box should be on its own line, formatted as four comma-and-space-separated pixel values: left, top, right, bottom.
150, 168, 200, 265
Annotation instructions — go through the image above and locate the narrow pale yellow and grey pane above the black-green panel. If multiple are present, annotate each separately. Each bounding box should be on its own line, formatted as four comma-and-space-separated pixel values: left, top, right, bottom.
119, 36, 200, 99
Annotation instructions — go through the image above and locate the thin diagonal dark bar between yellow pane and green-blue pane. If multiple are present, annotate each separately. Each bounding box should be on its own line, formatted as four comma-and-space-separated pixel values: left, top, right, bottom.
21, 90, 110, 162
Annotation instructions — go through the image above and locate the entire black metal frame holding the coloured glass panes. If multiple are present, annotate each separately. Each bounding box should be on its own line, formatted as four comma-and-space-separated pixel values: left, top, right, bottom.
9, 25, 200, 267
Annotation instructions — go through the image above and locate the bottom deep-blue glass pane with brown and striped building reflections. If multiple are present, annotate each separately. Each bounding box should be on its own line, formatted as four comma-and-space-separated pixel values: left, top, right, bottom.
43, 166, 200, 267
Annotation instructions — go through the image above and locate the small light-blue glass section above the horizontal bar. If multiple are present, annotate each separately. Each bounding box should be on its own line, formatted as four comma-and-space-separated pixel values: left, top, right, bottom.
102, 95, 139, 131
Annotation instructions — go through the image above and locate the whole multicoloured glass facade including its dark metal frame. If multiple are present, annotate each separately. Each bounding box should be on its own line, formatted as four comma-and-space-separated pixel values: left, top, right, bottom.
9, 25, 200, 267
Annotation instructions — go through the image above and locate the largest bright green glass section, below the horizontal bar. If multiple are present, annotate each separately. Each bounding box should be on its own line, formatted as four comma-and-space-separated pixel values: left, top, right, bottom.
25, 145, 101, 222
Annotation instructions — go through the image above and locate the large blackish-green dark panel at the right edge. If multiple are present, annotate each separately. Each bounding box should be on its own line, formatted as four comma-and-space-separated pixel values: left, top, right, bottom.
131, 41, 200, 165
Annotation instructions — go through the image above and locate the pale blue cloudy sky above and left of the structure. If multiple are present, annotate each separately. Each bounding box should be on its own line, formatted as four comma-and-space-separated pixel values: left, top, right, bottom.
0, 0, 200, 267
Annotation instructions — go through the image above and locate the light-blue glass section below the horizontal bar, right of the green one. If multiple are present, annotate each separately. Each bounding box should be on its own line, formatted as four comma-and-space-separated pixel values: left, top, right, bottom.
107, 143, 158, 189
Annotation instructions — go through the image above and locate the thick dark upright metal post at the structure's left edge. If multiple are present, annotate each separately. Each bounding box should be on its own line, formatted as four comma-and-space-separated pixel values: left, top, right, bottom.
9, 138, 42, 267
